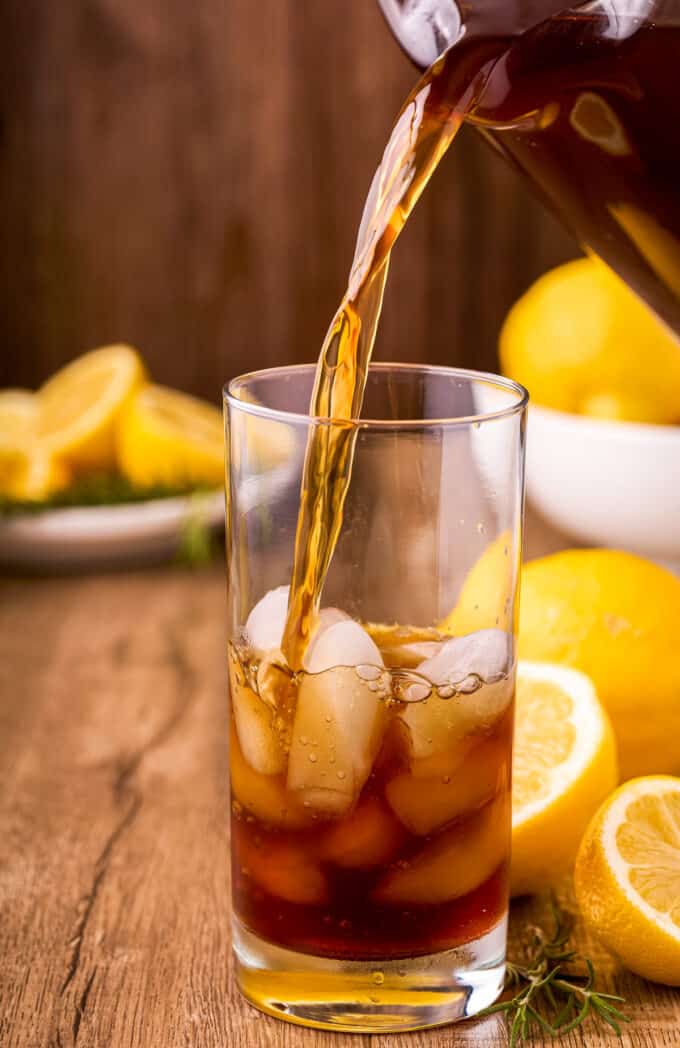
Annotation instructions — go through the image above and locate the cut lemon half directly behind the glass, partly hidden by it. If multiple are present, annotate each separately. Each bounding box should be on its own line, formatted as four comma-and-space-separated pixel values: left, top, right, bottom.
510, 662, 618, 895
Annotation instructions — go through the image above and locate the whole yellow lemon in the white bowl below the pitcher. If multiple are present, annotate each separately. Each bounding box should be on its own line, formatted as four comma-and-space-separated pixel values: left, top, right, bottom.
500, 258, 680, 422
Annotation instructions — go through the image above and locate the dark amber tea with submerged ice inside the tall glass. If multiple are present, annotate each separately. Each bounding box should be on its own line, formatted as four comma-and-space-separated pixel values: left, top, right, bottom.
229, 630, 513, 960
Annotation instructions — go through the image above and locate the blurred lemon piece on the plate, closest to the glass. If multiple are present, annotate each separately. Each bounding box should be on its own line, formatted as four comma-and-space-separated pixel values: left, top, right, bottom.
118, 386, 224, 487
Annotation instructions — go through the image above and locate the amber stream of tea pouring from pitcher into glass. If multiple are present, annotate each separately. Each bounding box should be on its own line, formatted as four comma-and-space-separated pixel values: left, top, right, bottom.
282, 42, 498, 670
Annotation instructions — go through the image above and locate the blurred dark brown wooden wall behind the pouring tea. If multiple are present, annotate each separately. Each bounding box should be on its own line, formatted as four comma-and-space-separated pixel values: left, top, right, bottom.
0, 0, 575, 399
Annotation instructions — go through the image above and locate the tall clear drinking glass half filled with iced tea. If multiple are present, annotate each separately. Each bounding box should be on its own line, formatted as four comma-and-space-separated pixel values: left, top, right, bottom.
225, 364, 527, 1032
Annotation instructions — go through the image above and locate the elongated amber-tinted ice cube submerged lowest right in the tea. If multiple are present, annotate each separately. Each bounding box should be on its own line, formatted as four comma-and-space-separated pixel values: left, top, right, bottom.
373, 793, 510, 907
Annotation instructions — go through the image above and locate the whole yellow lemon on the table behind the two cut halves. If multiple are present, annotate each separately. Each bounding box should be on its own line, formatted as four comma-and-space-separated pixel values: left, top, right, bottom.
519, 549, 680, 779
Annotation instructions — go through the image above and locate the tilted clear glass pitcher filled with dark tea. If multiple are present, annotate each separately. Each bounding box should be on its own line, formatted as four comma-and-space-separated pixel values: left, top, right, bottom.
378, 0, 680, 336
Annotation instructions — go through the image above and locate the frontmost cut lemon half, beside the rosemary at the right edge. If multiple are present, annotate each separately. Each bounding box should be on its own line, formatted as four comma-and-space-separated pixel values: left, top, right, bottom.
574, 776, 680, 986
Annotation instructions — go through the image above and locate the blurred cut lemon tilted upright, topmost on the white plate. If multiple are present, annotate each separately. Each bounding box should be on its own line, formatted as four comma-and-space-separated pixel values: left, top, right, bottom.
36, 346, 145, 470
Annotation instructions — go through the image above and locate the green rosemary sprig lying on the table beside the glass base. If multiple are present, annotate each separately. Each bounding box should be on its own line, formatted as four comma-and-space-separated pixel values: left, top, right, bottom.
481, 898, 630, 1048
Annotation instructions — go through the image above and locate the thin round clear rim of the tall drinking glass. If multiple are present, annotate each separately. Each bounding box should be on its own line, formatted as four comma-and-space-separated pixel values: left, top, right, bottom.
222, 361, 529, 430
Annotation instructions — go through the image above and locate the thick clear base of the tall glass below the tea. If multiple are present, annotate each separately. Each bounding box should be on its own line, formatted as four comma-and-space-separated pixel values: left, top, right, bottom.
232, 915, 507, 1033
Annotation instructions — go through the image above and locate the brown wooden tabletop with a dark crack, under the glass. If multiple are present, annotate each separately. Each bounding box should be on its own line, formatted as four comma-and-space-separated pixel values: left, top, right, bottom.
0, 523, 680, 1048
